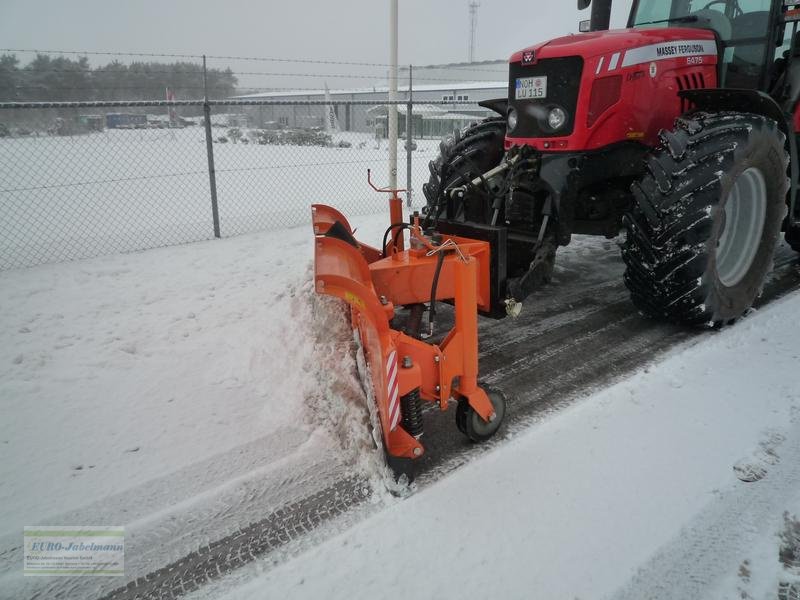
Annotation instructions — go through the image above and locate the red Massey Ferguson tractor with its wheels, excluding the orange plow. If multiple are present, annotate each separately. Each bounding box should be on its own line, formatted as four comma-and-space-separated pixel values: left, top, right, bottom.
424, 0, 800, 326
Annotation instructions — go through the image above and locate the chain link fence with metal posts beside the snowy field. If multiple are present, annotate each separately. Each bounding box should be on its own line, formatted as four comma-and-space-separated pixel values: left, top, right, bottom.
0, 101, 485, 270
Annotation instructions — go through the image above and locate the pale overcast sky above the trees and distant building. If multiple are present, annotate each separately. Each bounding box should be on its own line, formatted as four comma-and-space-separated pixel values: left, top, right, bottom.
0, 0, 630, 87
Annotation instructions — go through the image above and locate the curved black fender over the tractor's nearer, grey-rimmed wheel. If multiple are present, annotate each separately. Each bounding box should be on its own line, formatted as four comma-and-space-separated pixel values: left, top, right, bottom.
678, 88, 800, 227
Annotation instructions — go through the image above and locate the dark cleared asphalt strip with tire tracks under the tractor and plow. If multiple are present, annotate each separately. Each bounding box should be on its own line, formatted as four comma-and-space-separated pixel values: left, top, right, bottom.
103, 240, 800, 600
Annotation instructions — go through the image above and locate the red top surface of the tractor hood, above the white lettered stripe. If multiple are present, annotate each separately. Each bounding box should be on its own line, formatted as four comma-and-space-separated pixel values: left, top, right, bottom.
510, 27, 715, 64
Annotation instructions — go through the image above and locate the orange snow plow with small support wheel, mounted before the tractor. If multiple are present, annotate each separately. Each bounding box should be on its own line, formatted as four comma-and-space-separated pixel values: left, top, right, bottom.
312, 198, 505, 477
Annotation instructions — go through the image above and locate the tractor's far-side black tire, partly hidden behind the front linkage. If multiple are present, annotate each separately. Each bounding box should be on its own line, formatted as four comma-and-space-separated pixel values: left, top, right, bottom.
422, 117, 506, 223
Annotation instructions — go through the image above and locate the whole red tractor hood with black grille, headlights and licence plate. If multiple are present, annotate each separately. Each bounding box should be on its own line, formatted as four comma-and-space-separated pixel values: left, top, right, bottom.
506, 27, 719, 151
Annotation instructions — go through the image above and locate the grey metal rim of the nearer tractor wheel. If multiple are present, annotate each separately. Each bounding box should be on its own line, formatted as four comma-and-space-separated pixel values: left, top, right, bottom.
717, 167, 767, 287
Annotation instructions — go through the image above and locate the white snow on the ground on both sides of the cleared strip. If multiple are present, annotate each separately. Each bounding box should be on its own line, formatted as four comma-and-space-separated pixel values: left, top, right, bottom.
0, 198, 800, 600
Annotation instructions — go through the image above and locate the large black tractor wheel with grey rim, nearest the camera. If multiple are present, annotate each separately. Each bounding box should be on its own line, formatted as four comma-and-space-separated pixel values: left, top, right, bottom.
622, 112, 789, 326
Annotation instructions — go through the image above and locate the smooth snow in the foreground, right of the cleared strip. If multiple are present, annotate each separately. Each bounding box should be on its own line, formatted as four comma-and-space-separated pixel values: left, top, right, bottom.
194, 294, 800, 600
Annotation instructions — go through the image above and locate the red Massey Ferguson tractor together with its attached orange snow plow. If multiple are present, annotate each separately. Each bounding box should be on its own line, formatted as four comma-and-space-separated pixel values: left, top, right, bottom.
314, 0, 800, 478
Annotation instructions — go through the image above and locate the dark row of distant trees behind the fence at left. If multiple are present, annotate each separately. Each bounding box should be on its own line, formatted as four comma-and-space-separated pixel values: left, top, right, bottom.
0, 54, 237, 102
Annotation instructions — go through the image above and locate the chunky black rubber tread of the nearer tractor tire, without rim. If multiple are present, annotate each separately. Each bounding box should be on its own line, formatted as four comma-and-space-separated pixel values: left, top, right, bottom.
622, 112, 783, 326
